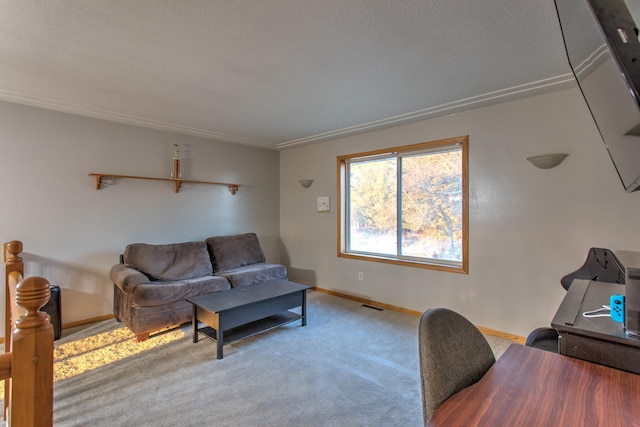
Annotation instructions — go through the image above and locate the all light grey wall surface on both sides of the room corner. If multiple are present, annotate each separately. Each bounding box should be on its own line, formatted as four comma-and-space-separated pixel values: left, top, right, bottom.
6, 89, 640, 342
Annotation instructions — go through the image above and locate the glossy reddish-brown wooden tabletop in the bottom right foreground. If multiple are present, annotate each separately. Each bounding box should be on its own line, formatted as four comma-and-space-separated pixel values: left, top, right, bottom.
428, 344, 640, 427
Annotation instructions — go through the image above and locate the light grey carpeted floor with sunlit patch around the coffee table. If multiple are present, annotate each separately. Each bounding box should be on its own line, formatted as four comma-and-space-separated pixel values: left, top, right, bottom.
0, 291, 510, 426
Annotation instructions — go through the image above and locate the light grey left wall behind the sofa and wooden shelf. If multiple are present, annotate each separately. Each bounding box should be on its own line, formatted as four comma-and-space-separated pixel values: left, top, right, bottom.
0, 102, 281, 331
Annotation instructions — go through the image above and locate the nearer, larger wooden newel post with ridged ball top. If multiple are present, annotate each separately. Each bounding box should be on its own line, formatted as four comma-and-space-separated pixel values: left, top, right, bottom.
9, 277, 54, 426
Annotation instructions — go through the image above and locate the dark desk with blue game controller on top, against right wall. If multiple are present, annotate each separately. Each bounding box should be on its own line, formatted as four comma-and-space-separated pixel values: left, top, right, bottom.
551, 280, 640, 374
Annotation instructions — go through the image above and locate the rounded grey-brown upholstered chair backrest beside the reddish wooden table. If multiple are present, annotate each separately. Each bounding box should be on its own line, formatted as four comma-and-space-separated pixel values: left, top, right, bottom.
418, 308, 496, 424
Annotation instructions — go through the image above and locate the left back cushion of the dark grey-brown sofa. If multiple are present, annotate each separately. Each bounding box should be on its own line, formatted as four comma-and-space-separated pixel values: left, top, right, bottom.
123, 242, 213, 281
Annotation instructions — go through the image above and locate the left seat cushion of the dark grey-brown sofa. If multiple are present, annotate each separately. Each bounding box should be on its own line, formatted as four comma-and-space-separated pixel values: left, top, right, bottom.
132, 276, 231, 307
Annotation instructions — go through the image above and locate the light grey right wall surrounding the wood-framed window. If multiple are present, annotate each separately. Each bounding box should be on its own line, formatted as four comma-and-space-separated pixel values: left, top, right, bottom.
280, 88, 640, 336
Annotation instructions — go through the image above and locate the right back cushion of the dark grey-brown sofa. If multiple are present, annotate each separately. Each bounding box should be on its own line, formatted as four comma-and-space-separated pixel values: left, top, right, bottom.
205, 233, 266, 273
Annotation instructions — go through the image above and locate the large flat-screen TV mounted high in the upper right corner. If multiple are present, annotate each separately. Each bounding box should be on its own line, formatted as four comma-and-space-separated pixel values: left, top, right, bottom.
555, 0, 640, 192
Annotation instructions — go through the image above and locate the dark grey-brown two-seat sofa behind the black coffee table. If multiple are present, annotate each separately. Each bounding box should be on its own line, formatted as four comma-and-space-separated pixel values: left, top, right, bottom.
110, 233, 287, 341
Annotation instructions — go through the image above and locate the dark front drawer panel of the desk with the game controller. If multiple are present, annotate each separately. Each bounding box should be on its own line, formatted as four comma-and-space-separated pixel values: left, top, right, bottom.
560, 332, 640, 374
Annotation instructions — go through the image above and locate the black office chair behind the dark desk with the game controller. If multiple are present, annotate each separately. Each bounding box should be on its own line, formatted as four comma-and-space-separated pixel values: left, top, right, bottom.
525, 248, 625, 353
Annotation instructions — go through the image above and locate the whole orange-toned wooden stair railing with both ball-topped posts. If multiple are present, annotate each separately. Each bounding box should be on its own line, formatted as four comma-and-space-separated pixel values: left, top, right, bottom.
0, 240, 54, 427
